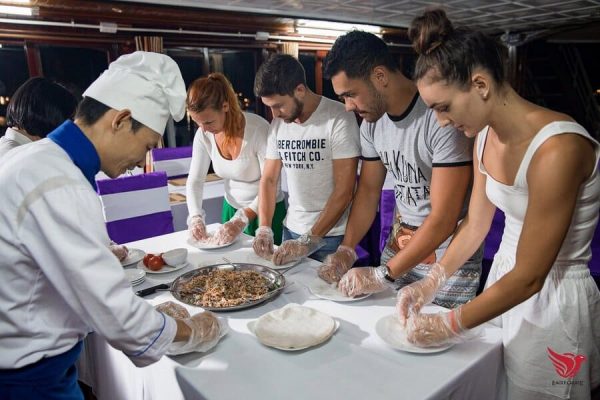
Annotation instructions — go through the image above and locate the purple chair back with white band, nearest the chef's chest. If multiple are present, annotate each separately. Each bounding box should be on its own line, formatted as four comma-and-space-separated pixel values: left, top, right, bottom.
97, 171, 174, 243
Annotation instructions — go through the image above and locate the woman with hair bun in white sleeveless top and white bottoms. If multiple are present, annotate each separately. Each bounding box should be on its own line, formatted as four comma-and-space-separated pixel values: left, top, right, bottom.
397, 10, 600, 399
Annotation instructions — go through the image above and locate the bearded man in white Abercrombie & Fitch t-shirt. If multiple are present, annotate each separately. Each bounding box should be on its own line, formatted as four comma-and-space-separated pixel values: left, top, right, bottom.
253, 54, 360, 265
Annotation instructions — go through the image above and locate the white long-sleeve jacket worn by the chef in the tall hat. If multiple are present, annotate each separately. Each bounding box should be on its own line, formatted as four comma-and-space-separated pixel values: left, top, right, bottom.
0, 139, 177, 369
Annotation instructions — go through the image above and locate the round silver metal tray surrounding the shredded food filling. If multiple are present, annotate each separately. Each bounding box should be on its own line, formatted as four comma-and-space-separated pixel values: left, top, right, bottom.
171, 263, 285, 311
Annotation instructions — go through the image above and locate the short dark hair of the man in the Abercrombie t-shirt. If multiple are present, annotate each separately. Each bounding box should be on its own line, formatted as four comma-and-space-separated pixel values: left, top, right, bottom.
254, 54, 306, 97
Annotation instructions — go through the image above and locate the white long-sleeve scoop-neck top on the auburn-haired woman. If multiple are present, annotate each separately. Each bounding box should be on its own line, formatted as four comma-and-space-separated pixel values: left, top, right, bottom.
186, 113, 283, 216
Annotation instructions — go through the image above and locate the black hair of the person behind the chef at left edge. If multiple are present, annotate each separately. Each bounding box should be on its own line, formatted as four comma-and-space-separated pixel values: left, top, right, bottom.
6, 77, 77, 138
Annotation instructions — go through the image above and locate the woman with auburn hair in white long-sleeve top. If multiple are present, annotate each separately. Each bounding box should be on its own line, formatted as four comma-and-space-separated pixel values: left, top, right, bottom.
186, 73, 285, 244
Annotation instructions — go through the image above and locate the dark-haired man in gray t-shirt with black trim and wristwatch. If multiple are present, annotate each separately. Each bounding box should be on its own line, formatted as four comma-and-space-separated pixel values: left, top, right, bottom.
319, 31, 481, 307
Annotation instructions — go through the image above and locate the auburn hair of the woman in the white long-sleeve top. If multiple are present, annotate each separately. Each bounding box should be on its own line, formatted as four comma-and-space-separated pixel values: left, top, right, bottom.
186, 72, 244, 144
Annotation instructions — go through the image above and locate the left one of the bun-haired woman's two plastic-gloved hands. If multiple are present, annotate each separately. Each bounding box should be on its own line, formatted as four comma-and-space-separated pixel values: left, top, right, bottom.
396, 263, 448, 325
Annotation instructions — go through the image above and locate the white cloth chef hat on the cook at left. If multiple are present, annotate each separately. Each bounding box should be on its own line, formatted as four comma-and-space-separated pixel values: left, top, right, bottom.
83, 51, 186, 135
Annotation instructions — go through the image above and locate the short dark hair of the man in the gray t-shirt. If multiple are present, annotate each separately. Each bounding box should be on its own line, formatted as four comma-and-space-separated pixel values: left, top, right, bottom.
323, 31, 400, 80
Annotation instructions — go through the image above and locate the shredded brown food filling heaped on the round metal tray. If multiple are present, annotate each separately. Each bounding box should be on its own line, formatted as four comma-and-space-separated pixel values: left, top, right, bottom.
179, 270, 269, 308
